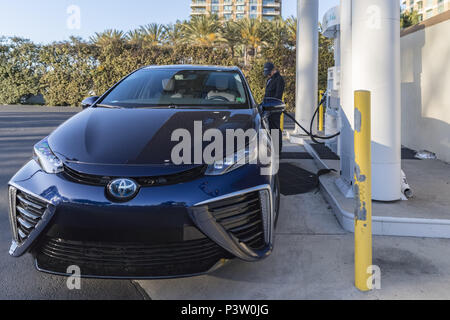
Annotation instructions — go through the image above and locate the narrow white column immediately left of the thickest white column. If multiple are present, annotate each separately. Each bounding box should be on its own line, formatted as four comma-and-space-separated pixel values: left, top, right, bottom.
339, 0, 355, 186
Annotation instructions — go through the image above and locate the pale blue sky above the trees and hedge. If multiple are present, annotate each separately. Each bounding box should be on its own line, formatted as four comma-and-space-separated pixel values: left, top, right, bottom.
0, 0, 339, 43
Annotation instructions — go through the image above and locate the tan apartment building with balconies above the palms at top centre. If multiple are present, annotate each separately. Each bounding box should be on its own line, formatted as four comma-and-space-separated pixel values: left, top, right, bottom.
191, 0, 281, 20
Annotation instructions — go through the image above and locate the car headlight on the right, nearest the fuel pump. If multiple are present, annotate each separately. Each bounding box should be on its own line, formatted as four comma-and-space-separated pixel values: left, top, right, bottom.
205, 131, 271, 176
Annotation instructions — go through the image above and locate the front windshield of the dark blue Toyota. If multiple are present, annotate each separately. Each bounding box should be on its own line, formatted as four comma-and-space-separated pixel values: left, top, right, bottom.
98, 68, 249, 108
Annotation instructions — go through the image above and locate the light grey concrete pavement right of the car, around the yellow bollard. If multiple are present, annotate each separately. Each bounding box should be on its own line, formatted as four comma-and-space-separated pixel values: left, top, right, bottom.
138, 143, 450, 300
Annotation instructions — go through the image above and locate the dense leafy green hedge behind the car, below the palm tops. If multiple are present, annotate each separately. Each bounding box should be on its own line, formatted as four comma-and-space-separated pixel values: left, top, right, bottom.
0, 38, 332, 110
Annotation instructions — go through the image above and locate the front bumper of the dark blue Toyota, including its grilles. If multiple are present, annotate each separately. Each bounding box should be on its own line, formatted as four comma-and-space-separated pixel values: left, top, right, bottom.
9, 161, 274, 278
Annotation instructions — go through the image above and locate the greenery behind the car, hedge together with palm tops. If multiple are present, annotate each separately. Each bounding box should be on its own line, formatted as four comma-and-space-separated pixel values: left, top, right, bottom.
0, 16, 334, 110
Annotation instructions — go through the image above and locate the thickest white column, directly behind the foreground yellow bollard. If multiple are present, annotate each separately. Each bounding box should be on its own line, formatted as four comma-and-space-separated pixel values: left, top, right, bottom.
352, 0, 401, 201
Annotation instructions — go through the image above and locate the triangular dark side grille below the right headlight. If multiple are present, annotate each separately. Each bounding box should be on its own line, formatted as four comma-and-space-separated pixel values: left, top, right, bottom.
208, 192, 266, 250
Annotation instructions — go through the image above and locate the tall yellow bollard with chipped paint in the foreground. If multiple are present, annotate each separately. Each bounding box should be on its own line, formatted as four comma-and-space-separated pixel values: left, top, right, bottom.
354, 91, 372, 291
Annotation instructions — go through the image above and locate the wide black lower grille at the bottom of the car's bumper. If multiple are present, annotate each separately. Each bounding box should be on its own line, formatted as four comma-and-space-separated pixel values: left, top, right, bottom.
35, 238, 231, 278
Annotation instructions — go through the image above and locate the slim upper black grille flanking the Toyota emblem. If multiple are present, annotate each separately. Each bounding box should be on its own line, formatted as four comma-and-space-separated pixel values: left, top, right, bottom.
62, 166, 206, 187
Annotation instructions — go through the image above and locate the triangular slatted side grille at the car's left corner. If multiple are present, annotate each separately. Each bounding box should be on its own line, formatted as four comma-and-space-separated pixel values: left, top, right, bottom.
11, 190, 47, 244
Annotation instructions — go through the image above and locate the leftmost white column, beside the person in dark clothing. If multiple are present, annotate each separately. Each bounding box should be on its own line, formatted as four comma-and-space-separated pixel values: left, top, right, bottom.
295, 0, 319, 134
